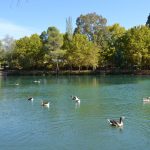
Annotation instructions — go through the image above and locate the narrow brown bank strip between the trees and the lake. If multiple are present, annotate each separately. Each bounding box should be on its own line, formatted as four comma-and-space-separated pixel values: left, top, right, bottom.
0, 69, 150, 76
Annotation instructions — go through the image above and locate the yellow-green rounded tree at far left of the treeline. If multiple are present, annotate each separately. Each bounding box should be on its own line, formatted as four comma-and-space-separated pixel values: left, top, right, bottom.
9, 34, 42, 69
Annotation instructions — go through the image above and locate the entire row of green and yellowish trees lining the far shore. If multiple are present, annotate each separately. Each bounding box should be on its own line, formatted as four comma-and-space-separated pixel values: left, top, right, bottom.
0, 13, 150, 71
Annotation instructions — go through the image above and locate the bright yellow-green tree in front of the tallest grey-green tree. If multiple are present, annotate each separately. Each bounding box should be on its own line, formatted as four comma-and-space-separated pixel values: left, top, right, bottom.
67, 34, 99, 71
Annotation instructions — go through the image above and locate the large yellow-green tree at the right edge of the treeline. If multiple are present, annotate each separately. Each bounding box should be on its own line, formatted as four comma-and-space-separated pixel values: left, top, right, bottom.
118, 26, 150, 69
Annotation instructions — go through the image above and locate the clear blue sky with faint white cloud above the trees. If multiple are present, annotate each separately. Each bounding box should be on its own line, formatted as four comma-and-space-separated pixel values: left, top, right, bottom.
0, 0, 150, 39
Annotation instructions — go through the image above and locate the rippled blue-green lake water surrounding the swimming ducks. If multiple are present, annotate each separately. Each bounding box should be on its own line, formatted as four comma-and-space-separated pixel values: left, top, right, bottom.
0, 76, 150, 150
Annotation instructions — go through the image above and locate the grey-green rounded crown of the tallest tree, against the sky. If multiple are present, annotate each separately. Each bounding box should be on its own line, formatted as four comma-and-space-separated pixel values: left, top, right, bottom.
75, 13, 107, 41
